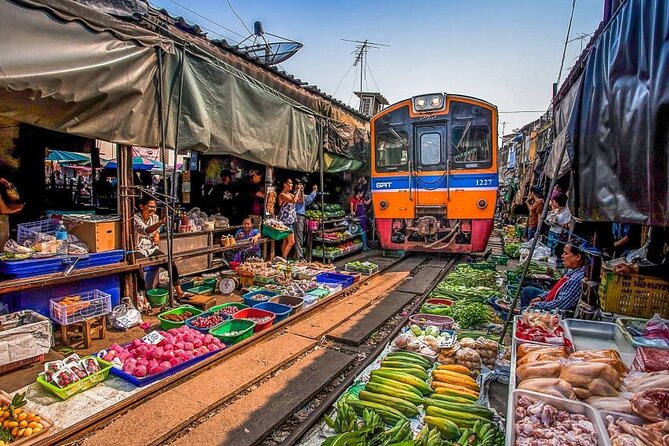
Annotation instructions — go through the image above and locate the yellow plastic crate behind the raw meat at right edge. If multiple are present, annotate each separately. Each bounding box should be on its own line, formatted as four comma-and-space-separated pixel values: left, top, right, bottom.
599, 269, 669, 319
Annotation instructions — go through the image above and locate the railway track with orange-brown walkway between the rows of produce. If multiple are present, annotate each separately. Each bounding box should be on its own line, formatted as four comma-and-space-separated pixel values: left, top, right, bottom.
58, 256, 458, 446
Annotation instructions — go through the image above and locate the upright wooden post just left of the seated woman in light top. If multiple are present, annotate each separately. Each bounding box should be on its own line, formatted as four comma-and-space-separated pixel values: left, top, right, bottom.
116, 145, 137, 303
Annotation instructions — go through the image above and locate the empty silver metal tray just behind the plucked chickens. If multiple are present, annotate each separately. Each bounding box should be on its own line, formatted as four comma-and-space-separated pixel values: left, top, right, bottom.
564, 319, 636, 367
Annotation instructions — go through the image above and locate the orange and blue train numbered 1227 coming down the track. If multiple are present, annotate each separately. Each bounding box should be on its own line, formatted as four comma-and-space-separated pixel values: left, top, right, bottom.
371, 93, 498, 253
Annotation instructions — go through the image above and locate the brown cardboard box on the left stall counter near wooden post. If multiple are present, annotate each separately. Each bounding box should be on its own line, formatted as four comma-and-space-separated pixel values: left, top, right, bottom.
63, 215, 121, 252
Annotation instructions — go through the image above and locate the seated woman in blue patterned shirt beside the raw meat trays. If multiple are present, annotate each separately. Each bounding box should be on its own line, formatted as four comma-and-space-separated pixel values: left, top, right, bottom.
520, 245, 586, 311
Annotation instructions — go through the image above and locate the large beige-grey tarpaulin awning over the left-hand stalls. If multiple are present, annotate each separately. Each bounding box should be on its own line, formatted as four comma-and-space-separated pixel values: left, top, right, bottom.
0, 0, 319, 172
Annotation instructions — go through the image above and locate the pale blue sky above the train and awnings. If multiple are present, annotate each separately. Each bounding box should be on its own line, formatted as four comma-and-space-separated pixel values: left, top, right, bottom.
150, 0, 603, 134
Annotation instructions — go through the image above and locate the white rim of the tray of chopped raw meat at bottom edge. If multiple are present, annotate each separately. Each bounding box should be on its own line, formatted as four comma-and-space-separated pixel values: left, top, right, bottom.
506, 390, 611, 446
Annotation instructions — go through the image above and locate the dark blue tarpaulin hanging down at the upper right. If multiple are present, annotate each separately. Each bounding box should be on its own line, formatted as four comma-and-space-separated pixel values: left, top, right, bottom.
551, 0, 669, 226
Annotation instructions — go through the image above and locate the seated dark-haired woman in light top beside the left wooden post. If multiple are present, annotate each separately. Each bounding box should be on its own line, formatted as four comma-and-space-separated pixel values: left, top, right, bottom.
132, 195, 183, 298
